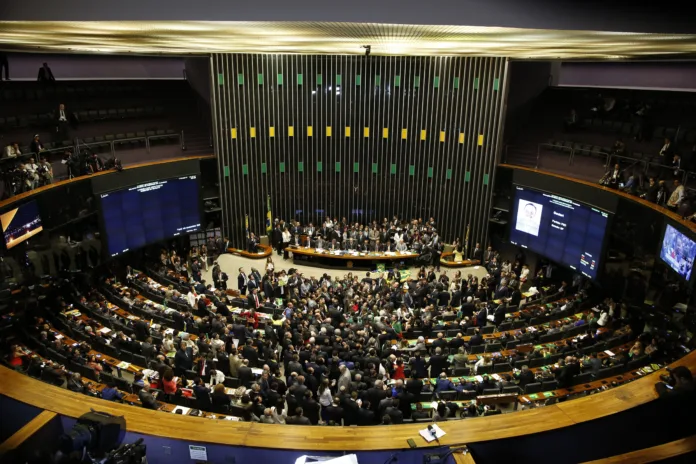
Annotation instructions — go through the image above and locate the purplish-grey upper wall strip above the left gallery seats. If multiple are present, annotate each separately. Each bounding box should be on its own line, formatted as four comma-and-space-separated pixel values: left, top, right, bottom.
2, 53, 184, 81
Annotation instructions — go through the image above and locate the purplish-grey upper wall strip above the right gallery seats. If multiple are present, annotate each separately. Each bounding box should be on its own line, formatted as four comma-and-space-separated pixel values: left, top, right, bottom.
558, 61, 696, 91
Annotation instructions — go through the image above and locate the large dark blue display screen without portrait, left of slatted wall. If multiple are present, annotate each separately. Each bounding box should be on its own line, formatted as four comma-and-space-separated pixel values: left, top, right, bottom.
100, 175, 201, 256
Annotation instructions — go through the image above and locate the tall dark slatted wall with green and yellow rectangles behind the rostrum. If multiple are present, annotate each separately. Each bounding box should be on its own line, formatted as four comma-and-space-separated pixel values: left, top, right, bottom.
212, 55, 507, 245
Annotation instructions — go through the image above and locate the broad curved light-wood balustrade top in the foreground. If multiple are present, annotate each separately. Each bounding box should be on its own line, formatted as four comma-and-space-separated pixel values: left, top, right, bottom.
0, 351, 696, 451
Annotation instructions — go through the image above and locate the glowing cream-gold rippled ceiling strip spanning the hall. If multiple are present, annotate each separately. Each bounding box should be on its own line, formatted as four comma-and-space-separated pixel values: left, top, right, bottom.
0, 21, 696, 59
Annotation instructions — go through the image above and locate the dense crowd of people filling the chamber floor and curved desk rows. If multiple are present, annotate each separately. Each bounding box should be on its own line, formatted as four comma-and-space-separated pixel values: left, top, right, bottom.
4, 230, 680, 425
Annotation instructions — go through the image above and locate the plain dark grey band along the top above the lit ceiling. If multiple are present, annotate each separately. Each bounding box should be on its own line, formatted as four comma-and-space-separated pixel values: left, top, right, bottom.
0, 0, 696, 33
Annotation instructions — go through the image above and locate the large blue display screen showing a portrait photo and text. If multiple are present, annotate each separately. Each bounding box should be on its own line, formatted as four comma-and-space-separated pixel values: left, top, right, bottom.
510, 186, 609, 279
